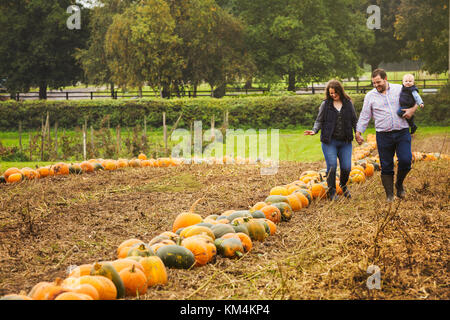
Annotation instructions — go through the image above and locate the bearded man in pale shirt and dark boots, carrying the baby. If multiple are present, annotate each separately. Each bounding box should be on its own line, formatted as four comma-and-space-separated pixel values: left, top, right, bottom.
356, 69, 418, 202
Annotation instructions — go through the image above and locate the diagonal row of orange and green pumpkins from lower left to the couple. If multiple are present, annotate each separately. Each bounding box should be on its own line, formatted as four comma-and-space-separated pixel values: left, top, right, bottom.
1, 134, 448, 300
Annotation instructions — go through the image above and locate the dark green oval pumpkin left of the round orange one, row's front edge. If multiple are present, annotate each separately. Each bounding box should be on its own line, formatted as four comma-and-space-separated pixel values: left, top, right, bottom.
156, 244, 195, 269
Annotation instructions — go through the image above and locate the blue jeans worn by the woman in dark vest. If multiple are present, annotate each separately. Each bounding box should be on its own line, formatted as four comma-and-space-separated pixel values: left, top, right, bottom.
322, 139, 353, 187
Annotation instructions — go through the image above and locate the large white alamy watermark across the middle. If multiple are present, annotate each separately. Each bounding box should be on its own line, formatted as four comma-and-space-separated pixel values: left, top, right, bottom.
170, 121, 280, 175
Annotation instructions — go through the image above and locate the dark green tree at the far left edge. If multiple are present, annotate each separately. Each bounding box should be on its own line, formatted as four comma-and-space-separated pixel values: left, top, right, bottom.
0, 0, 89, 99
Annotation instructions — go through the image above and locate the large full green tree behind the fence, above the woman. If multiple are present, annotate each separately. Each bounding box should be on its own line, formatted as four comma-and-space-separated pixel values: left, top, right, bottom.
232, 0, 371, 90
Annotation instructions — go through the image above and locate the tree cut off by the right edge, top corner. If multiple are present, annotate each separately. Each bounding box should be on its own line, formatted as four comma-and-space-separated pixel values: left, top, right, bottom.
395, 0, 449, 73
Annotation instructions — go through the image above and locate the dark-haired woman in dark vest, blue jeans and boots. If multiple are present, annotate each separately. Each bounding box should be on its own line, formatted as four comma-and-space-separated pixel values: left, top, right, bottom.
304, 80, 357, 200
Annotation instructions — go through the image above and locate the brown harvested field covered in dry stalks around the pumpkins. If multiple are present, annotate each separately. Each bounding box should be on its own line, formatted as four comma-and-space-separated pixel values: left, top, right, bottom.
0, 136, 450, 300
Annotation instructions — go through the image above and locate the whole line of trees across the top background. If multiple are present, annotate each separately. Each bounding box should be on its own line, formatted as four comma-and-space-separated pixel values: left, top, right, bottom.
0, 0, 449, 99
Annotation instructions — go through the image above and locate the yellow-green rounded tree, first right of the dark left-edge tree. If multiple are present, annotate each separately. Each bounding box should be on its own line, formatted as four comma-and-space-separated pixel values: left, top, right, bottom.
105, 0, 183, 96
